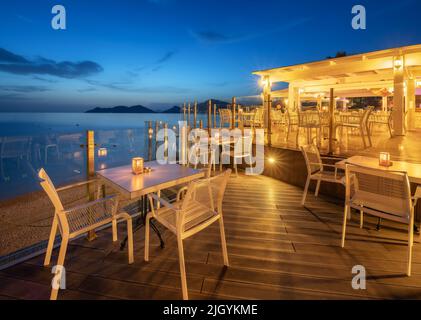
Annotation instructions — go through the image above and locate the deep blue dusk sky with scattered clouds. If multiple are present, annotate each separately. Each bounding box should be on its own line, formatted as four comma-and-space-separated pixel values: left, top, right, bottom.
0, 0, 421, 112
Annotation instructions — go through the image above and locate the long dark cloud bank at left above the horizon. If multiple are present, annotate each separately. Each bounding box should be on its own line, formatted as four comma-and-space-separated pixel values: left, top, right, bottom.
0, 48, 103, 79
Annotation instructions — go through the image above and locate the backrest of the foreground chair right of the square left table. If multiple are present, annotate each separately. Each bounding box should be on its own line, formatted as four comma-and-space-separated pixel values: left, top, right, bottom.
178, 169, 231, 228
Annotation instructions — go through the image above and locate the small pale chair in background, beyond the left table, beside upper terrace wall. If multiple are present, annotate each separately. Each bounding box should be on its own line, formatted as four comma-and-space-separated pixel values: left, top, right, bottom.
219, 134, 253, 176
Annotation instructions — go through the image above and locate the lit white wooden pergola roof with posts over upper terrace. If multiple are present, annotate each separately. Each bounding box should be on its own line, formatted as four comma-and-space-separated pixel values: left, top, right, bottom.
253, 45, 421, 145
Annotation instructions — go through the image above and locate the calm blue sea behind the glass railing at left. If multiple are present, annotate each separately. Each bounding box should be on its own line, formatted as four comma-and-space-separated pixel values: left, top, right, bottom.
0, 113, 206, 200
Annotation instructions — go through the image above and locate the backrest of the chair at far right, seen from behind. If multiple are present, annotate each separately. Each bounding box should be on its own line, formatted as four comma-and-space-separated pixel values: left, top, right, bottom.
346, 164, 412, 219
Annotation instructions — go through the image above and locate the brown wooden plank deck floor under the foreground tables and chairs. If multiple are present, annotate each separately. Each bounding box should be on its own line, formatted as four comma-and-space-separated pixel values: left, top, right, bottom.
0, 176, 421, 299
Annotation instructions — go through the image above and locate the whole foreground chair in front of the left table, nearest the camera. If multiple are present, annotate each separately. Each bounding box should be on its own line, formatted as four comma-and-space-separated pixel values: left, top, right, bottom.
145, 170, 231, 300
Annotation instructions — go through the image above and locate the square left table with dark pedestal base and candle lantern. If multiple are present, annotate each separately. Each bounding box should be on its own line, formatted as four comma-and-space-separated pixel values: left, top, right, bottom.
96, 161, 204, 248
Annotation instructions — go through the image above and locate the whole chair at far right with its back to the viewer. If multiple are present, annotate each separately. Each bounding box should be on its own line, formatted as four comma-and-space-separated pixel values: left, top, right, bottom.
341, 164, 421, 276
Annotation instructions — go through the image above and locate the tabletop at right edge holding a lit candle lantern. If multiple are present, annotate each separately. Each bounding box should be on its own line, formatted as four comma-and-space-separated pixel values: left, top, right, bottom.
336, 156, 421, 185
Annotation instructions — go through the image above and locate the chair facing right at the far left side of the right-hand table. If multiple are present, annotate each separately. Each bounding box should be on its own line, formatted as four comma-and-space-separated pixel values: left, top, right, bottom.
301, 144, 345, 206
